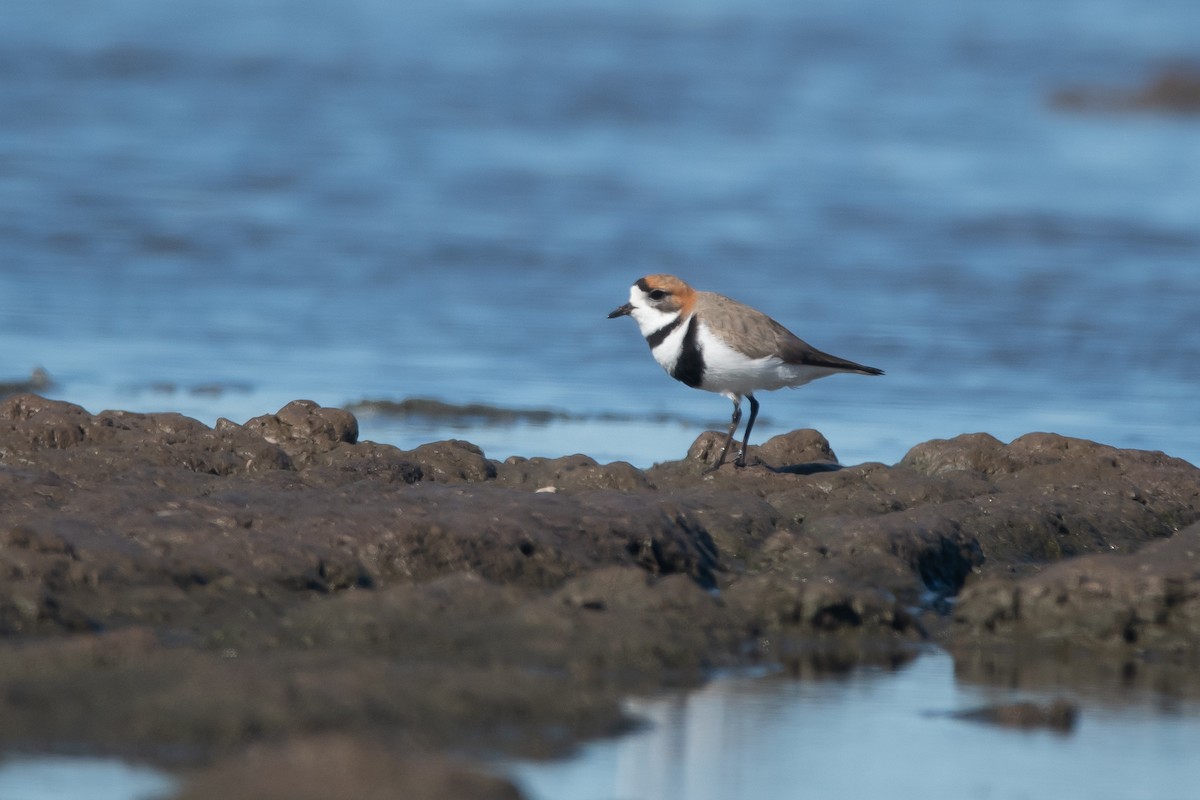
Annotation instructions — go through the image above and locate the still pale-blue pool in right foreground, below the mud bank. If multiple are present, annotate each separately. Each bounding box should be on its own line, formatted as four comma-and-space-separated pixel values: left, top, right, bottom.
508, 654, 1200, 800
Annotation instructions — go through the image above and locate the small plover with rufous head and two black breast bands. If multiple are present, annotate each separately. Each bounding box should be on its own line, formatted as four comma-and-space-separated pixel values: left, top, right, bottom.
608, 275, 883, 470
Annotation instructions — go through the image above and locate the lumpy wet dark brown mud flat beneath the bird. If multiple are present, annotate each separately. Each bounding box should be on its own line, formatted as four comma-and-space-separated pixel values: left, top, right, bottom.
0, 395, 1200, 800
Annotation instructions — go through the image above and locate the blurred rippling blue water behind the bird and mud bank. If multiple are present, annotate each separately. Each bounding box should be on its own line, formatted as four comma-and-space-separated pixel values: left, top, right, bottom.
0, 0, 1200, 465
